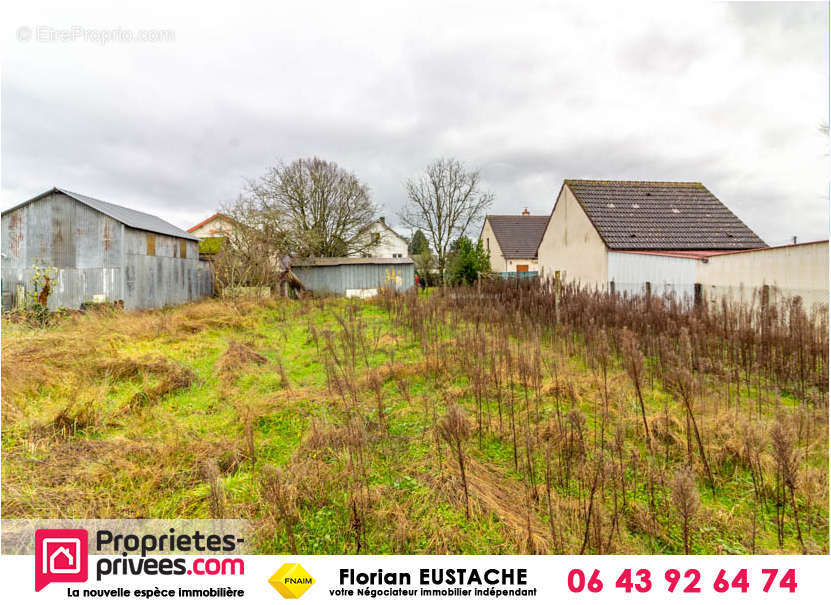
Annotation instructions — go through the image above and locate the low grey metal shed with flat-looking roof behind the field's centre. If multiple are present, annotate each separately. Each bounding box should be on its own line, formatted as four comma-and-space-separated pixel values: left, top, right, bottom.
292, 258, 415, 297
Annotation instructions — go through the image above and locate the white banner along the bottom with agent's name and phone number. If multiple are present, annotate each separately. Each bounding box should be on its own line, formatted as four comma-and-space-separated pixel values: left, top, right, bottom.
0, 553, 831, 604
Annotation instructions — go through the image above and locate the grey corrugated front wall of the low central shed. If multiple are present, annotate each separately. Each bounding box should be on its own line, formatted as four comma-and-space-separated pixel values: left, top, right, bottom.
292, 263, 415, 296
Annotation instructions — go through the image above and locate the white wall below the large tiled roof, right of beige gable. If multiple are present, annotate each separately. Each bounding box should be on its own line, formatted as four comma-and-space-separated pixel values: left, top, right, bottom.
609, 250, 699, 302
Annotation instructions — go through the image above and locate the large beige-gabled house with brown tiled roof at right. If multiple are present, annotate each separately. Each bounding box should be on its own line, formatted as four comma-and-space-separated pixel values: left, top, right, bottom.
537, 180, 766, 293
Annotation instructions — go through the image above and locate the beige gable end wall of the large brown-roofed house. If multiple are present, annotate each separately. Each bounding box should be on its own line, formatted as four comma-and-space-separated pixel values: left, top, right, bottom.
537, 185, 609, 288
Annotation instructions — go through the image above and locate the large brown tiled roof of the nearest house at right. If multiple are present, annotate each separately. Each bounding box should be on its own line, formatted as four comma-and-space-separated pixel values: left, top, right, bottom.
564, 179, 766, 250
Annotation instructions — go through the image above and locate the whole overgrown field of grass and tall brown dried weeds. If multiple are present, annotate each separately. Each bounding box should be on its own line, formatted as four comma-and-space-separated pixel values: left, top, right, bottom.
2, 283, 829, 554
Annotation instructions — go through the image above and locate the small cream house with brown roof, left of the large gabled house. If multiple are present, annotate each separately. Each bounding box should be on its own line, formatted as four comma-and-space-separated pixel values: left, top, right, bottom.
479, 208, 548, 273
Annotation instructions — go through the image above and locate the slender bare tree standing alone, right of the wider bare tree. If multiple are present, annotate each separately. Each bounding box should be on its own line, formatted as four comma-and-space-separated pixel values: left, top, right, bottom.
400, 158, 493, 280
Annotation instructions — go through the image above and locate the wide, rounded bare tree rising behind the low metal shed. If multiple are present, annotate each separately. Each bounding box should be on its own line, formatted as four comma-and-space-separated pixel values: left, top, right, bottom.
243, 157, 377, 257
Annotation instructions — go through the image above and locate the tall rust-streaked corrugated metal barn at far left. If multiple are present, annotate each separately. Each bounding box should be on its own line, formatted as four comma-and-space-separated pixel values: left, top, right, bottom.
0, 187, 213, 310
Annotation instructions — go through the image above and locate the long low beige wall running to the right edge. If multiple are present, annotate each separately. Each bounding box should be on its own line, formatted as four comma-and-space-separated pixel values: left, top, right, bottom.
696, 241, 828, 309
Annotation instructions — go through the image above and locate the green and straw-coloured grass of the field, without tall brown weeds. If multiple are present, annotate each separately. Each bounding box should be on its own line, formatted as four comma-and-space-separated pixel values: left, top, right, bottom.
2, 299, 828, 554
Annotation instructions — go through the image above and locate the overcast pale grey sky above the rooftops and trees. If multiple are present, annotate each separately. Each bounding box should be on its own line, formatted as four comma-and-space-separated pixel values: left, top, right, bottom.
0, 1, 828, 244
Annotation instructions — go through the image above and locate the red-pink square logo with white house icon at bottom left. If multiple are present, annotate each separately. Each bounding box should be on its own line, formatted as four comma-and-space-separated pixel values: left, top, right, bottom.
35, 529, 89, 592
